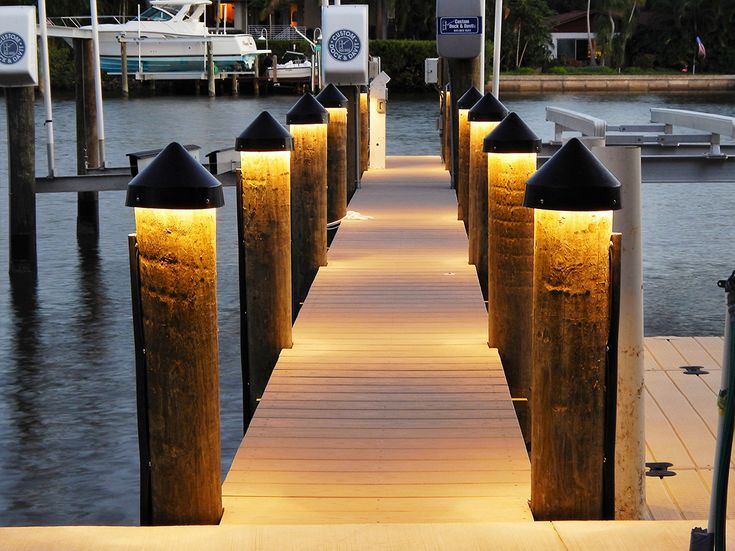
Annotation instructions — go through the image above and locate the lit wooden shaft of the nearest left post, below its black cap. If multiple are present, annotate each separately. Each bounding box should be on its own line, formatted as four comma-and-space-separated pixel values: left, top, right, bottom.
135, 207, 221, 524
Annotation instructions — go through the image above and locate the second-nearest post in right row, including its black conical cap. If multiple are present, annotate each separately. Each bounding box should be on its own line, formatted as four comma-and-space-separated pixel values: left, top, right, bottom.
483, 113, 541, 444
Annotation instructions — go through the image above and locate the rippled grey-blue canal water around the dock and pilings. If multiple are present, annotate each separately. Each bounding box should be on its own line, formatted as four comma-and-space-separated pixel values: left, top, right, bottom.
0, 91, 735, 525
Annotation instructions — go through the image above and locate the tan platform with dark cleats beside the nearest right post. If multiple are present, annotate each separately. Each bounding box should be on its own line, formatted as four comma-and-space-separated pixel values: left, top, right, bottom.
645, 337, 735, 520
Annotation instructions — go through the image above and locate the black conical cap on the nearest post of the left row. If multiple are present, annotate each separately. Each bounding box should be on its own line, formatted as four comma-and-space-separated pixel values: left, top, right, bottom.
125, 142, 225, 209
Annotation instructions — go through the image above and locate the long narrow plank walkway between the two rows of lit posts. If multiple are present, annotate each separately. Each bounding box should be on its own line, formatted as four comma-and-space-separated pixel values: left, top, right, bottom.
223, 157, 531, 524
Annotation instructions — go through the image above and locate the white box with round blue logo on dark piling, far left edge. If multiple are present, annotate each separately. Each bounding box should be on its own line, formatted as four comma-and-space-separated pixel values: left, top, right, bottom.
0, 6, 38, 274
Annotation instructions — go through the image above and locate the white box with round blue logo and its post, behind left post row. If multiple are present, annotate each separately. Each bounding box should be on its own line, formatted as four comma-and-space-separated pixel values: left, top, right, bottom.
322, 4, 369, 200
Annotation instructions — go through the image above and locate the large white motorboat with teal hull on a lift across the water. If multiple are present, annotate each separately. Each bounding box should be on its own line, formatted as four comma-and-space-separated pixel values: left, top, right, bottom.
72, 0, 264, 73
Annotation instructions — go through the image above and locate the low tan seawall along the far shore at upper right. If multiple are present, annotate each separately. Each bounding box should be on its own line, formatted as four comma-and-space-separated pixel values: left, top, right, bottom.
498, 73, 735, 94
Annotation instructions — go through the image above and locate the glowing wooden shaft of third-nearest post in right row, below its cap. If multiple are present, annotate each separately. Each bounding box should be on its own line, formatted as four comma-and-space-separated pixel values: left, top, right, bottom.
466, 121, 500, 266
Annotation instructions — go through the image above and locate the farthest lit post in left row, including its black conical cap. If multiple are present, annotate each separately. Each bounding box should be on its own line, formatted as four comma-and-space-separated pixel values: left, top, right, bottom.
316, 84, 347, 223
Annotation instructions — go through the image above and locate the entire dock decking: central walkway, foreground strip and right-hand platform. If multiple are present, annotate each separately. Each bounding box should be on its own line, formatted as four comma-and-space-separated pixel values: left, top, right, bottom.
0, 157, 735, 551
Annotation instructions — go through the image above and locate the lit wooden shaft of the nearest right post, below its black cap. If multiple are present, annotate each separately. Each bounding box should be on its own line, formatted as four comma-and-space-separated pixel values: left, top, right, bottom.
531, 209, 612, 520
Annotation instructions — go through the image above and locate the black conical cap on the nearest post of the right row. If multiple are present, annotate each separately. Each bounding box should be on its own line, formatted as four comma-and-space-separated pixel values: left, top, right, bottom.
523, 138, 621, 211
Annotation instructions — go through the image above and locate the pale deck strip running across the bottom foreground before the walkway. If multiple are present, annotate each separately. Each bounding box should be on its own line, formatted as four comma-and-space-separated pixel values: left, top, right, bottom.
7, 521, 735, 551
